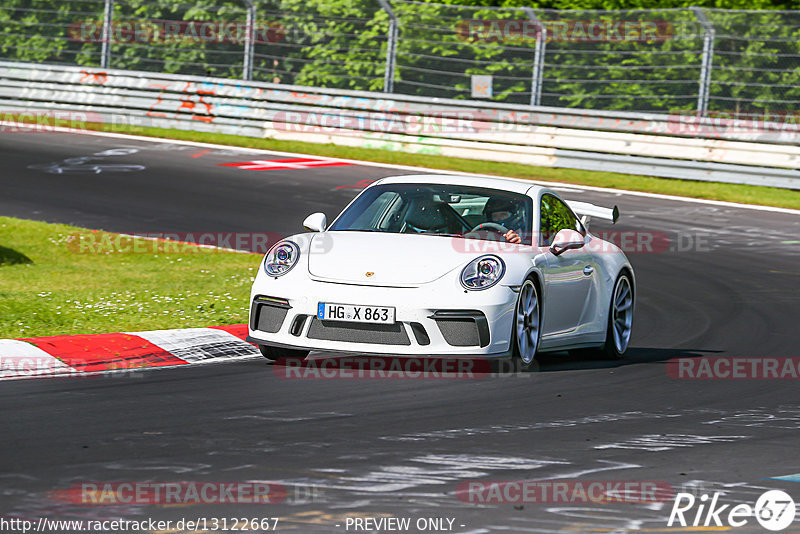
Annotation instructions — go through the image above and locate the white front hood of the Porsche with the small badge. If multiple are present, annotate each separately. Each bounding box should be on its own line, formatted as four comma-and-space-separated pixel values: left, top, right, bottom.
308, 231, 471, 286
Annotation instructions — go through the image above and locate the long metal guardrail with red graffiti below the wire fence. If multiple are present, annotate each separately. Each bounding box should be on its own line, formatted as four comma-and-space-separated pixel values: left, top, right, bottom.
0, 62, 800, 189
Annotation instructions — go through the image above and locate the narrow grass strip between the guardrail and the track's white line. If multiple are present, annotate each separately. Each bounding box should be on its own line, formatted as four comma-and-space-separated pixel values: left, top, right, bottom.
85, 124, 800, 213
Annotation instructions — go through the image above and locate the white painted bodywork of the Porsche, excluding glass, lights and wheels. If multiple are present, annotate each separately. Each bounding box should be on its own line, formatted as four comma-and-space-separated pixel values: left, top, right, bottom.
249, 175, 635, 357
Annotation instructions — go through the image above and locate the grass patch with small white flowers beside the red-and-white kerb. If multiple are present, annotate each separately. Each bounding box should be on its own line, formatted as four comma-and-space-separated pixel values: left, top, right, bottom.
0, 217, 260, 338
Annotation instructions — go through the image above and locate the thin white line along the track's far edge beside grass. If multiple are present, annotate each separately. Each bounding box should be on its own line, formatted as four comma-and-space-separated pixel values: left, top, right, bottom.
47, 127, 800, 215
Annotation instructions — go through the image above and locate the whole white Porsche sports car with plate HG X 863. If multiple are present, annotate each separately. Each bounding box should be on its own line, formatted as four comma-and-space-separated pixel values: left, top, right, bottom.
248, 175, 635, 366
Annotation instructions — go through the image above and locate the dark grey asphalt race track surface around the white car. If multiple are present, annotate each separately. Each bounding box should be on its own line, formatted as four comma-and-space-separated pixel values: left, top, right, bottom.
0, 133, 800, 533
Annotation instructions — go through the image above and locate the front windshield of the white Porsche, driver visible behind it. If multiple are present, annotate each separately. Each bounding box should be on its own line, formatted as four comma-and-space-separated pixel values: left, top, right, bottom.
330, 184, 533, 245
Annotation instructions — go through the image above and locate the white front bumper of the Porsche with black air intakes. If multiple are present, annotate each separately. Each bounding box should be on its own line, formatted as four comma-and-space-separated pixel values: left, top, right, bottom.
248, 276, 517, 357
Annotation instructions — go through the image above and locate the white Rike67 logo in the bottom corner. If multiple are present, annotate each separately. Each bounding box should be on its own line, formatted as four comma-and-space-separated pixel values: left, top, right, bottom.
667, 490, 796, 531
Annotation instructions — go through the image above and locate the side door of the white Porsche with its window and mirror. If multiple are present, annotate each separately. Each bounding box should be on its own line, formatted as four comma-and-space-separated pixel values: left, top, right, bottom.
539, 193, 596, 335
